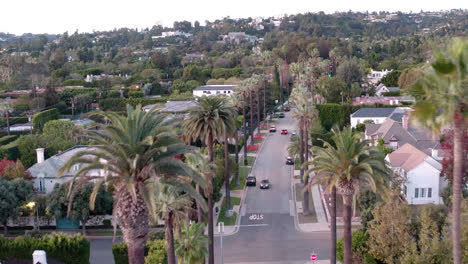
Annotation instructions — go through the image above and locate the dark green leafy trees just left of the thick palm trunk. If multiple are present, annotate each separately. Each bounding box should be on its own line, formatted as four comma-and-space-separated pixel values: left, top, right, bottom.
47, 183, 113, 234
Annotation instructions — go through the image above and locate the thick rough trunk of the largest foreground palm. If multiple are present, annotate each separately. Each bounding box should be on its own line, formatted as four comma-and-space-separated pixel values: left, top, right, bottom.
117, 188, 148, 264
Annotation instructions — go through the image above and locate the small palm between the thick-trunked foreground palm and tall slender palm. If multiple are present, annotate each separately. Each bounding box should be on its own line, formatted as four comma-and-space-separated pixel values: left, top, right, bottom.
151, 185, 192, 264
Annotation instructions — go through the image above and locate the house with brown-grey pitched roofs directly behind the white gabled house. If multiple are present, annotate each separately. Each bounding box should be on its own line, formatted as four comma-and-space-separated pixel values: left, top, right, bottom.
364, 117, 440, 153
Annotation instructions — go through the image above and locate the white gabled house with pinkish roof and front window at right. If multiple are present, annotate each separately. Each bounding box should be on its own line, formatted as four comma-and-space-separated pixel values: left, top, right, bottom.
385, 143, 447, 205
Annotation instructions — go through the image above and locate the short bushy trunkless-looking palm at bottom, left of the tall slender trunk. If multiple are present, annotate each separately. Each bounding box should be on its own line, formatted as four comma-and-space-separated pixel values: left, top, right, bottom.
175, 223, 208, 264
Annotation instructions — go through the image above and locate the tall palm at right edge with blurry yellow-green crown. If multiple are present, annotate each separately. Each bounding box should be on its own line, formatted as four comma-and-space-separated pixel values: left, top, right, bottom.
411, 39, 468, 264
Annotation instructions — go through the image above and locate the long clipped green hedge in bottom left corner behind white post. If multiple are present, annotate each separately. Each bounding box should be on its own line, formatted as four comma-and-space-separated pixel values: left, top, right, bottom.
0, 233, 90, 264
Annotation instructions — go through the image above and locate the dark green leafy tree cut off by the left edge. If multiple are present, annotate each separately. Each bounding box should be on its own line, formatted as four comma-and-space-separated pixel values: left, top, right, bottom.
0, 178, 33, 236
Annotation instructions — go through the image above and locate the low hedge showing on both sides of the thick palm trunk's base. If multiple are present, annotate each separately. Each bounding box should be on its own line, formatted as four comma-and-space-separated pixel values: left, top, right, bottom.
112, 240, 167, 264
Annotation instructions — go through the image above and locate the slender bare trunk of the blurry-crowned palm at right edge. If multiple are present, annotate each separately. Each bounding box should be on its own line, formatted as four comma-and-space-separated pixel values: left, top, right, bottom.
452, 118, 464, 264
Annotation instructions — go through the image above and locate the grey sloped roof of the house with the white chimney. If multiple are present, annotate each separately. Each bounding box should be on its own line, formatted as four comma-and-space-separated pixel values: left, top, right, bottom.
28, 145, 88, 178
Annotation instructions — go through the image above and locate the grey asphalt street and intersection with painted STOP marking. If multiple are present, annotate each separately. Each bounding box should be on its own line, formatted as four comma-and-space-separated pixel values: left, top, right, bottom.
215, 112, 330, 263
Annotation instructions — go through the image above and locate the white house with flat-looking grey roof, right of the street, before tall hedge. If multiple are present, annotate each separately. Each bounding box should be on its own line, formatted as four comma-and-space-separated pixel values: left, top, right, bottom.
350, 107, 409, 128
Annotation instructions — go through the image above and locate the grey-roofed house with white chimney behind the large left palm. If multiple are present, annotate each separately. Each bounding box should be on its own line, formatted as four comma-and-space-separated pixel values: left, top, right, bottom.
28, 146, 104, 194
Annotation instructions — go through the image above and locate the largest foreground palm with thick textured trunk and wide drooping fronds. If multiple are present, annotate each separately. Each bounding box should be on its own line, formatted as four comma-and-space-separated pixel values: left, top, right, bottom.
57, 105, 200, 264
